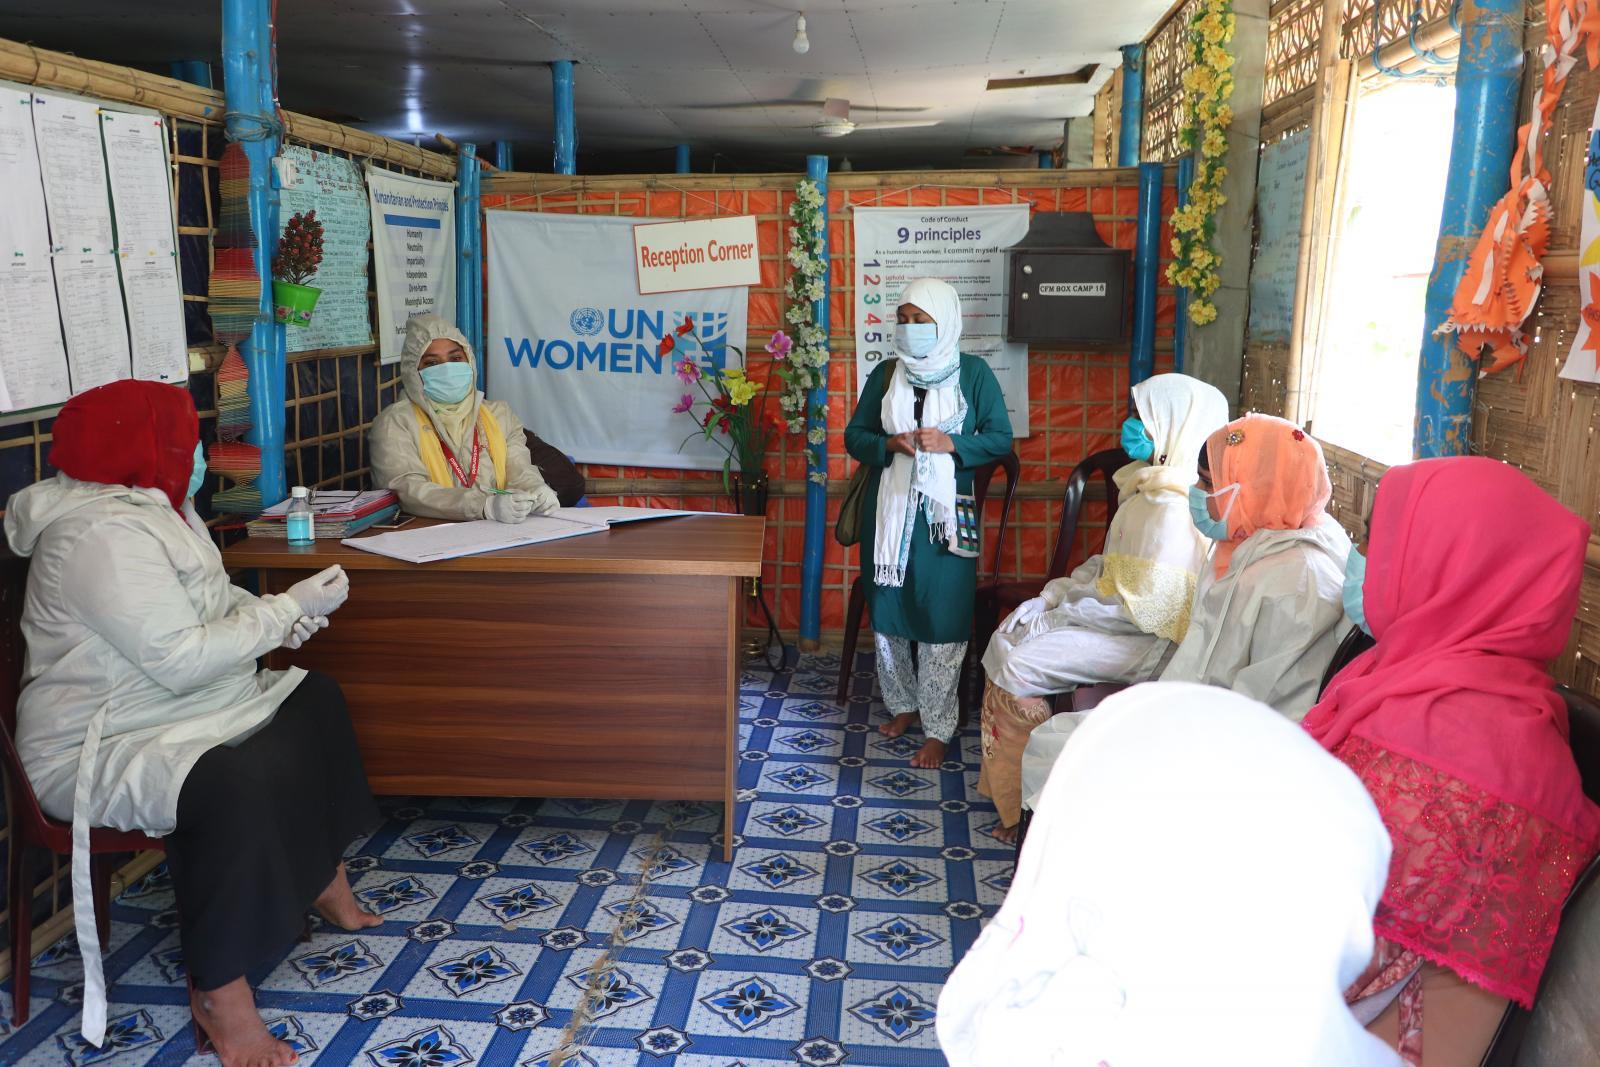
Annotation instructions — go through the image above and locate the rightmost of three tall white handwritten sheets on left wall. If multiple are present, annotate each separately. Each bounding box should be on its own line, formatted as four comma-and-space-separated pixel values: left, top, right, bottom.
99, 110, 189, 382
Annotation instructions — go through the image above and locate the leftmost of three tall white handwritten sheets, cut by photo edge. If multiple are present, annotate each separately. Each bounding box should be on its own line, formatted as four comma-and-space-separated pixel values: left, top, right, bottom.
0, 86, 72, 411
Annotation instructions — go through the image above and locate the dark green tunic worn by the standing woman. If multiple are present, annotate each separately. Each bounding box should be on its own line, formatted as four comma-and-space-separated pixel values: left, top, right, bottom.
845, 354, 1011, 645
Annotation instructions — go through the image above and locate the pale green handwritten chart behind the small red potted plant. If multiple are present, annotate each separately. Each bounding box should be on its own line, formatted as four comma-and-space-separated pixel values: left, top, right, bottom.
278, 144, 373, 352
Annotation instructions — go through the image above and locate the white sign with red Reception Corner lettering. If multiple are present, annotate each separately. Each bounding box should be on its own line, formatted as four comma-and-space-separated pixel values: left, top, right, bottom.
634, 214, 762, 296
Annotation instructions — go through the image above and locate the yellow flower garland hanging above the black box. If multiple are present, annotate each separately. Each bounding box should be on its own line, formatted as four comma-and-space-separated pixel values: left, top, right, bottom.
1166, 0, 1234, 326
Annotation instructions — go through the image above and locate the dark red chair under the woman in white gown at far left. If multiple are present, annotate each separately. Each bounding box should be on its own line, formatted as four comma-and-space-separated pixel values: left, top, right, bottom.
0, 557, 165, 1025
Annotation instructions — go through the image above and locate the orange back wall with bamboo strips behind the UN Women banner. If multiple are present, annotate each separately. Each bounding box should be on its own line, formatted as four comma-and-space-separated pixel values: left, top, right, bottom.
483, 168, 1176, 637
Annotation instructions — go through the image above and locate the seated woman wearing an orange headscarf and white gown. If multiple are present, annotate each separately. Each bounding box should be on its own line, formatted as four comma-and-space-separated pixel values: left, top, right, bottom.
1022, 414, 1350, 808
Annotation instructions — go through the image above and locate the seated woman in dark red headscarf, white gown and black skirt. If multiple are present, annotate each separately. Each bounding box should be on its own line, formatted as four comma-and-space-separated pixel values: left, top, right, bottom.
5, 381, 379, 1067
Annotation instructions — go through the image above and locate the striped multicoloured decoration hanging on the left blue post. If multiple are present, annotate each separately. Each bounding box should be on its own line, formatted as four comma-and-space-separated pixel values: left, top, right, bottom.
208, 142, 261, 515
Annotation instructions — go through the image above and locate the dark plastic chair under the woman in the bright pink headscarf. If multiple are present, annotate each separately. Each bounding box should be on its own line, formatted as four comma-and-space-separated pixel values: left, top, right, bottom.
1482, 685, 1600, 1067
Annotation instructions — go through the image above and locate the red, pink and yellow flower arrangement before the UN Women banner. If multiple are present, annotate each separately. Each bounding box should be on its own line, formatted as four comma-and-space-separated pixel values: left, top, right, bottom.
661, 318, 787, 515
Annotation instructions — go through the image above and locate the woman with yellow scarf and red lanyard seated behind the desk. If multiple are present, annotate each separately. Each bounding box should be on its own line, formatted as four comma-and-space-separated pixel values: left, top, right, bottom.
370, 315, 560, 523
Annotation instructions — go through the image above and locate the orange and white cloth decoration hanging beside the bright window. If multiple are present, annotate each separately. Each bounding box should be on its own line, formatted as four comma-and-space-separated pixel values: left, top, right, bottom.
1434, 0, 1600, 374
